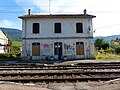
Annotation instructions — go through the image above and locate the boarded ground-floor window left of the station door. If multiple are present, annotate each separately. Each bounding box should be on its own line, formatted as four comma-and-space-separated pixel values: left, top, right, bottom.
32, 43, 40, 56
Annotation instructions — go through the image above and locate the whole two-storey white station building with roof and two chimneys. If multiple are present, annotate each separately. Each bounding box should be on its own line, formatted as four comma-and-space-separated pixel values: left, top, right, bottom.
19, 10, 96, 60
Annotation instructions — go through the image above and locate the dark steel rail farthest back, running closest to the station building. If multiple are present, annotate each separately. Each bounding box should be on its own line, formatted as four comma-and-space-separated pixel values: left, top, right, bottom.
0, 62, 120, 68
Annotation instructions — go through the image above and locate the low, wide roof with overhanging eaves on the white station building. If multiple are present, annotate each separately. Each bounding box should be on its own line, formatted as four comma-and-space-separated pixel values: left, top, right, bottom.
18, 14, 96, 19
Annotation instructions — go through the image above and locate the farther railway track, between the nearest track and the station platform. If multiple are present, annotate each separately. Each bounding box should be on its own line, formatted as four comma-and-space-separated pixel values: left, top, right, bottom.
0, 64, 120, 70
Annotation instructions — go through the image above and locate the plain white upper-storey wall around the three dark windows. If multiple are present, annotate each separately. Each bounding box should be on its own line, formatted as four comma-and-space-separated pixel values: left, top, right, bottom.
23, 19, 92, 38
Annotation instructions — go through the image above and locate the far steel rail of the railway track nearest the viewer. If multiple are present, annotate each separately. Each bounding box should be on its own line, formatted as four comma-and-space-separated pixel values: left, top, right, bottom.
0, 71, 120, 76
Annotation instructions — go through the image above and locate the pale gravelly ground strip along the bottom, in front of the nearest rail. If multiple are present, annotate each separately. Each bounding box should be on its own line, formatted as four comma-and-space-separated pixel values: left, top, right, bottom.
0, 79, 120, 90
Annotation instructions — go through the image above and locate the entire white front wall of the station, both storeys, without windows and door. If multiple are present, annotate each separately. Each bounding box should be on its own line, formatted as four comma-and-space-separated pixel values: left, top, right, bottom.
22, 18, 94, 59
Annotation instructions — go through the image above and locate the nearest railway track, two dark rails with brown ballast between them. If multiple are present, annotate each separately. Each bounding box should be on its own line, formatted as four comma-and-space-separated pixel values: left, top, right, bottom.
0, 71, 120, 82
